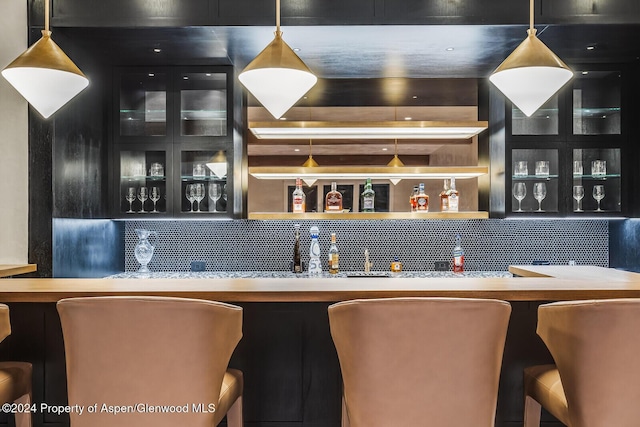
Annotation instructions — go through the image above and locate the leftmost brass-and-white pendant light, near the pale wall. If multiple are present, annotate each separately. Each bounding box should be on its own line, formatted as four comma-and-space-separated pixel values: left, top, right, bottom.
2, 0, 89, 119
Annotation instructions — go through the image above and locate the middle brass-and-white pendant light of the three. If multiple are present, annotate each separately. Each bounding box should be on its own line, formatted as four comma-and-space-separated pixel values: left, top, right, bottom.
238, 0, 318, 119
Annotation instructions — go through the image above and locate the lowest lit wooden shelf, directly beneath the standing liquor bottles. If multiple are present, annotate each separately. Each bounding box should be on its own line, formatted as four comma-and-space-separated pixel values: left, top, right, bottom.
248, 211, 489, 220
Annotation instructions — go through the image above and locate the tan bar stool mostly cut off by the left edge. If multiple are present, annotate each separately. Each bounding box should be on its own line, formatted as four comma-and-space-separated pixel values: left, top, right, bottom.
0, 304, 32, 427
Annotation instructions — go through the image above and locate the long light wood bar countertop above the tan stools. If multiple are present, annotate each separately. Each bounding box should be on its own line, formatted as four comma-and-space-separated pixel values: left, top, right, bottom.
0, 266, 640, 302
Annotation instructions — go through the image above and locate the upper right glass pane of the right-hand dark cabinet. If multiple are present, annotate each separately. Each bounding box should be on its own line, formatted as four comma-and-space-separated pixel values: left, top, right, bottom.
573, 70, 621, 135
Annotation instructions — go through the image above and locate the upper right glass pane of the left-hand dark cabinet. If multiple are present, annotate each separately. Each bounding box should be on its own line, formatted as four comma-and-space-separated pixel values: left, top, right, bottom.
178, 72, 227, 136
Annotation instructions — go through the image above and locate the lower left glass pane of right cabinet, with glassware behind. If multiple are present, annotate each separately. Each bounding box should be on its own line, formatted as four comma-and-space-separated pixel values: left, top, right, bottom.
511, 149, 559, 214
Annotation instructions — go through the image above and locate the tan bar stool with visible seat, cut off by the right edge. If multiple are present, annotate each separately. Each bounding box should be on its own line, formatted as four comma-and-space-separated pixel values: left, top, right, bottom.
524, 299, 640, 427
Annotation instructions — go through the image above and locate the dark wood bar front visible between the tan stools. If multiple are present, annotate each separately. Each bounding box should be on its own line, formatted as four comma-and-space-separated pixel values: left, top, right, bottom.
0, 301, 560, 427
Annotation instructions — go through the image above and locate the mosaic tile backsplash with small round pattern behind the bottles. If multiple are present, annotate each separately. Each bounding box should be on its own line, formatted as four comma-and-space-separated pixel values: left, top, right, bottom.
124, 219, 609, 271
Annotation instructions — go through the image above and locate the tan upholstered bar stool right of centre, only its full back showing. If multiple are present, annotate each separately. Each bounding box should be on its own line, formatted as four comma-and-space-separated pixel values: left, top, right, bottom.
329, 298, 511, 427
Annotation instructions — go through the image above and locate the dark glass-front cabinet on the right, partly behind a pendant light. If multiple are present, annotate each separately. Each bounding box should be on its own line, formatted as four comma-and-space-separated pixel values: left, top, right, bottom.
505, 66, 629, 217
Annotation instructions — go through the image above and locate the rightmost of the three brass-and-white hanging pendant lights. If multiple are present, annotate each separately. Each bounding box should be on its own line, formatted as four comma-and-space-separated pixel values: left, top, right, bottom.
489, 0, 573, 117
